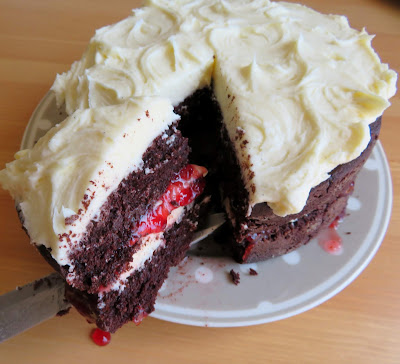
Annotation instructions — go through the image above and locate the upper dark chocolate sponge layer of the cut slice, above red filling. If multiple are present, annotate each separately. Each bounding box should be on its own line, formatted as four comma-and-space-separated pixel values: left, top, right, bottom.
39, 126, 189, 293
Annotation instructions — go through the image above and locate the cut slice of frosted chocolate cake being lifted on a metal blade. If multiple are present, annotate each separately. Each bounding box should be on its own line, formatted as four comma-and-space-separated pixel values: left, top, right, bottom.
0, 97, 207, 332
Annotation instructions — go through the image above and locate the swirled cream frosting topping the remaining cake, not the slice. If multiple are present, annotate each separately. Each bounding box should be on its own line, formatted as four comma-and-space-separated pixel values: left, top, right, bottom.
52, 0, 397, 216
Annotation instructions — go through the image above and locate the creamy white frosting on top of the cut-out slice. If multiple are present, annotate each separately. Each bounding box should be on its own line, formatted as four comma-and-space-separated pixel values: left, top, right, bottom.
0, 97, 178, 264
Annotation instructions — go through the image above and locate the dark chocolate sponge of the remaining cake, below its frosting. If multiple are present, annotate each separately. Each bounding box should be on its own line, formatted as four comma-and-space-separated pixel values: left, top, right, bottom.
175, 87, 381, 262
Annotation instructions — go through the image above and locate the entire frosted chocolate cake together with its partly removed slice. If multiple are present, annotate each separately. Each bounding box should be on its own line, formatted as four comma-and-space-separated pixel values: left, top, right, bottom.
0, 0, 397, 331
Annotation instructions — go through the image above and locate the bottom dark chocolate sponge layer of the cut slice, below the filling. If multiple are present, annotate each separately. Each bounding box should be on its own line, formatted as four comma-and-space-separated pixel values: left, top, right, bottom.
66, 205, 199, 332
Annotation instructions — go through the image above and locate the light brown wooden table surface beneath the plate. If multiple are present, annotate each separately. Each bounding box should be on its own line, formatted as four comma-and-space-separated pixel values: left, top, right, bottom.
0, 0, 400, 363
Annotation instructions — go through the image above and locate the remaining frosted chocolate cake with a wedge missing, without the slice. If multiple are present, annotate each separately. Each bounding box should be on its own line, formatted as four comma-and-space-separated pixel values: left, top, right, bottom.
52, 0, 397, 261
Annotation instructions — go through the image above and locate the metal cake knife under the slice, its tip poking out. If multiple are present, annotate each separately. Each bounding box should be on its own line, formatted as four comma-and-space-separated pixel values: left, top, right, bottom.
0, 213, 225, 343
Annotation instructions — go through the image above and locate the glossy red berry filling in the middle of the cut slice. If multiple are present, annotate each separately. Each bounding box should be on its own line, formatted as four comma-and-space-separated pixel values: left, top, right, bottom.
130, 164, 207, 245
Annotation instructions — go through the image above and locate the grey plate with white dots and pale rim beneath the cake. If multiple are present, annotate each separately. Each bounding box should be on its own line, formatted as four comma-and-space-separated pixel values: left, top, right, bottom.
22, 94, 392, 327
